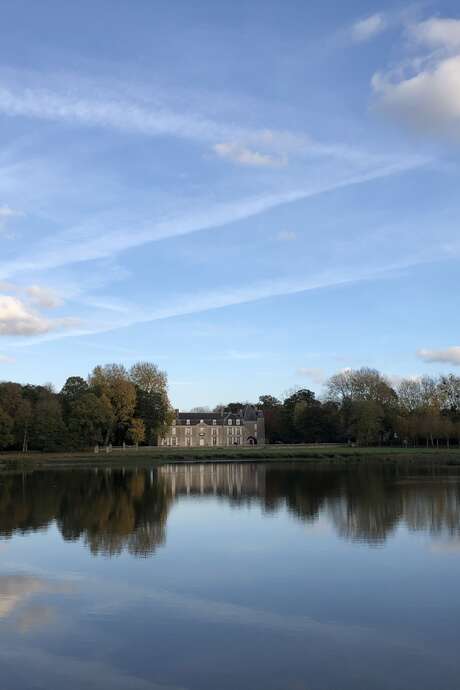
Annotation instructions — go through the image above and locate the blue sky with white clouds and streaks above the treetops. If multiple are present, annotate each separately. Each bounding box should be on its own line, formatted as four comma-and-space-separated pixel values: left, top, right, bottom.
0, 0, 460, 409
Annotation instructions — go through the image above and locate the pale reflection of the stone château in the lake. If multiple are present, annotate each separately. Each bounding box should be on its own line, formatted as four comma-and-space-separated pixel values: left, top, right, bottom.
158, 463, 265, 498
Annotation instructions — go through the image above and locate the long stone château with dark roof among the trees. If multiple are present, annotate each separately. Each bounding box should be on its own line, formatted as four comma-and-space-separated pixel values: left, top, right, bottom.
158, 405, 265, 448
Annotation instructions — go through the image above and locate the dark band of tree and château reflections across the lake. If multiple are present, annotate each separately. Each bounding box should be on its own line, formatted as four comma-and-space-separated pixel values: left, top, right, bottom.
0, 464, 460, 557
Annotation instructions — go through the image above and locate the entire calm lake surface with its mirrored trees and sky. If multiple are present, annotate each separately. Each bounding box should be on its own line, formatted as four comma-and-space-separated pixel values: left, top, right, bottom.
0, 463, 460, 690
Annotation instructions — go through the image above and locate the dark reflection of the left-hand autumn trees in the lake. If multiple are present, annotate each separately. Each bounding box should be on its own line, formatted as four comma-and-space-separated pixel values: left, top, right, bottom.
0, 470, 171, 556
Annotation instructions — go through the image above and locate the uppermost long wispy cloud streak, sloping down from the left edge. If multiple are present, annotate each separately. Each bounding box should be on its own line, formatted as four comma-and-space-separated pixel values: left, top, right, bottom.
0, 72, 416, 167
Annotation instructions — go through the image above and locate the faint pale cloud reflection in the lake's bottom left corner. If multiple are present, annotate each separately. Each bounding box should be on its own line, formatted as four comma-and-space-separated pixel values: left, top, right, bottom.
0, 646, 184, 690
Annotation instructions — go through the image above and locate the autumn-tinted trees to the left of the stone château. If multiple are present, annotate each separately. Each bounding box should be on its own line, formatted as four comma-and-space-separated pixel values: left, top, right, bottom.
0, 362, 171, 452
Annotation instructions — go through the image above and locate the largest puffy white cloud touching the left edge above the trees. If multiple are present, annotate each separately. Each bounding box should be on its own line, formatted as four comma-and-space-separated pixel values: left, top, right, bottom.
0, 295, 76, 336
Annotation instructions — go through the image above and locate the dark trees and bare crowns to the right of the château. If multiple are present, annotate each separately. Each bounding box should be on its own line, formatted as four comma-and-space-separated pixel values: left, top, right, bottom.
234, 367, 460, 448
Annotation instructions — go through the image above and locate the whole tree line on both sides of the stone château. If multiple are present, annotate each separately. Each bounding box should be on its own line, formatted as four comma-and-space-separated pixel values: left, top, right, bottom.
0, 362, 460, 451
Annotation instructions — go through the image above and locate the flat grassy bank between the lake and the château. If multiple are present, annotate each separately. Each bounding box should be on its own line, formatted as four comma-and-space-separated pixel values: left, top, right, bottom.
0, 445, 460, 469
